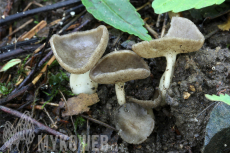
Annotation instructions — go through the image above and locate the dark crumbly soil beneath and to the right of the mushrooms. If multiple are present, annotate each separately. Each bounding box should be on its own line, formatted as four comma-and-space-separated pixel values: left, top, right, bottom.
0, 0, 230, 153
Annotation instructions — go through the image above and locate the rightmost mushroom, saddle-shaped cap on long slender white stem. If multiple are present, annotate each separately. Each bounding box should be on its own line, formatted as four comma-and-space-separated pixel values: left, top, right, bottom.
132, 17, 204, 105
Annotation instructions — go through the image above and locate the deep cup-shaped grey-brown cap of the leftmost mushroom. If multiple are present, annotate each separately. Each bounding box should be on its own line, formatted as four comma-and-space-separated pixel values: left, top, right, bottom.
50, 25, 109, 74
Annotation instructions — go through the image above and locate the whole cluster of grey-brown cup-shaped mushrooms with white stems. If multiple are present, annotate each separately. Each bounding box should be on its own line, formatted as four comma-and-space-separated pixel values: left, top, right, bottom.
50, 17, 204, 144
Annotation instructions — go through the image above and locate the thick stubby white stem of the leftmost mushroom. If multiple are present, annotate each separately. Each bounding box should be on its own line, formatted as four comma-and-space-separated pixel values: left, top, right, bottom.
69, 71, 98, 94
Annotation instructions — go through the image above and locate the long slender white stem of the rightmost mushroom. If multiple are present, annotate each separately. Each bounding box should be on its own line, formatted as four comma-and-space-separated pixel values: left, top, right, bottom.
159, 51, 177, 105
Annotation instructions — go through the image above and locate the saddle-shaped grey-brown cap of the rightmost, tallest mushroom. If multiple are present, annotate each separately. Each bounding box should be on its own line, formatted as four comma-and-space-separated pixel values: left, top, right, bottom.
132, 17, 204, 58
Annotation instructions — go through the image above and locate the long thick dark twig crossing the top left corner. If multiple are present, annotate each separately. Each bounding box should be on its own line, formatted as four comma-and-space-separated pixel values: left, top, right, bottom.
0, 0, 80, 25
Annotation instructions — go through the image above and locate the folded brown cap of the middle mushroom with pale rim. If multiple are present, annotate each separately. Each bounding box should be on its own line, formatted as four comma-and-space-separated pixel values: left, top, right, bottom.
89, 50, 150, 84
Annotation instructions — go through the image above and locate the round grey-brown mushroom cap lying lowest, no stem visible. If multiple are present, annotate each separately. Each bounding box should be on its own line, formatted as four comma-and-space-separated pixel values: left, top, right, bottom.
115, 103, 155, 144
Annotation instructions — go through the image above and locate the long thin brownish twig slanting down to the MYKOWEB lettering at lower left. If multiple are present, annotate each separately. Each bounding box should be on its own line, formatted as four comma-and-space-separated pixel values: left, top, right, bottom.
0, 106, 70, 140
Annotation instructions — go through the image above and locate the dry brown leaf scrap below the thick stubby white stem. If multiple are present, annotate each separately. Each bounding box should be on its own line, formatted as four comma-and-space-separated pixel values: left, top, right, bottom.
62, 93, 100, 117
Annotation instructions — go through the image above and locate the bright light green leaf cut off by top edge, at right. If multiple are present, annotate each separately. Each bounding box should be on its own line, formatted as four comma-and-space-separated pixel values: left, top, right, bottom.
152, 0, 225, 14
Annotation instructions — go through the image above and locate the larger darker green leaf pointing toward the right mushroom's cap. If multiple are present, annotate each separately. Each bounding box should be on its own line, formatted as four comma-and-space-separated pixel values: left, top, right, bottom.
82, 0, 152, 41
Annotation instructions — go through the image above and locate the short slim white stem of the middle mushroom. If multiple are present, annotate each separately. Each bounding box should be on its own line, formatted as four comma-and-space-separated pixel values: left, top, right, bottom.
115, 82, 126, 105
